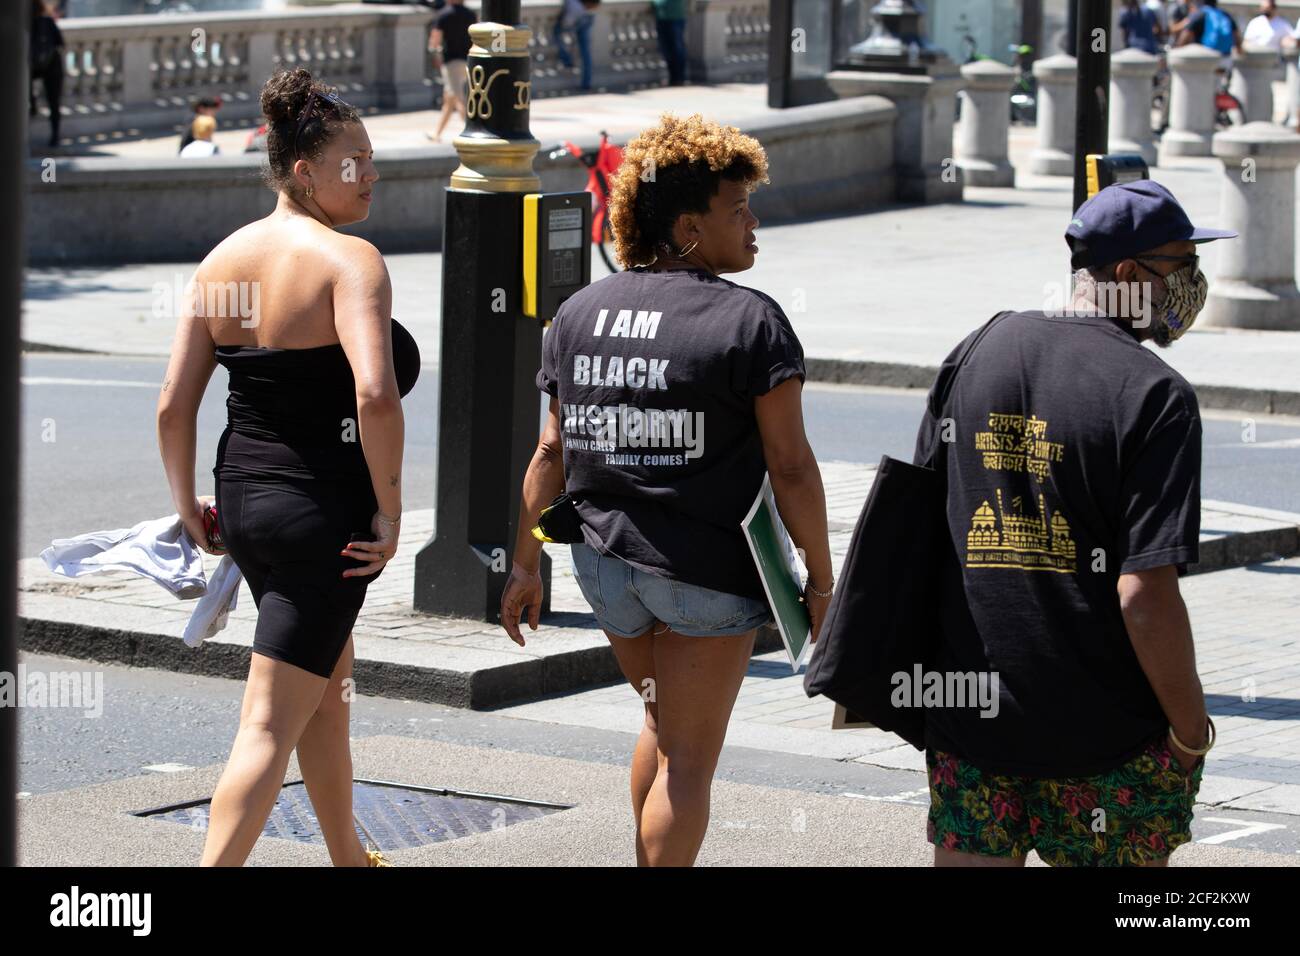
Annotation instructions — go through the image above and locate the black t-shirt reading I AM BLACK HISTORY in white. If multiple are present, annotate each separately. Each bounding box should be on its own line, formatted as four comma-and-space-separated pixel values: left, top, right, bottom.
537, 269, 803, 600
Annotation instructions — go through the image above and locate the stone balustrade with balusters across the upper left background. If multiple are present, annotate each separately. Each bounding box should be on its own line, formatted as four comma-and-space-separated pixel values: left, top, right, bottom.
33, 0, 768, 138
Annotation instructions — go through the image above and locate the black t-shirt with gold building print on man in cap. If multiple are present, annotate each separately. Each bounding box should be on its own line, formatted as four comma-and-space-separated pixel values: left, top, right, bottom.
914, 312, 1201, 778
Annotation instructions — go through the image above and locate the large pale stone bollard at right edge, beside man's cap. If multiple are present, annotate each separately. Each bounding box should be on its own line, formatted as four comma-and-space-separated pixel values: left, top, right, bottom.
1204, 122, 1300, 332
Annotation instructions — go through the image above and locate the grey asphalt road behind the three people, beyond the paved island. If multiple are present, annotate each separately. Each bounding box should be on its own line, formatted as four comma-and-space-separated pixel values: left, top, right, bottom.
21, 354, 1300, 557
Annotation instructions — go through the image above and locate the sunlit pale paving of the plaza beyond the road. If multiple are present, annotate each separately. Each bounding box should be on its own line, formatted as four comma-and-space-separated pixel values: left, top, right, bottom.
15, 85, 1300, 414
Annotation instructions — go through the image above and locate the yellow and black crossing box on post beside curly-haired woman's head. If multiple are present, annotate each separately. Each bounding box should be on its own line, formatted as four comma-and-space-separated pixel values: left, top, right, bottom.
523, 190, 592, 324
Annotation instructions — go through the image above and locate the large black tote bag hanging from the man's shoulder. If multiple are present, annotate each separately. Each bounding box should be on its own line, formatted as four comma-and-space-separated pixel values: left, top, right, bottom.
803, 312, 1006, 750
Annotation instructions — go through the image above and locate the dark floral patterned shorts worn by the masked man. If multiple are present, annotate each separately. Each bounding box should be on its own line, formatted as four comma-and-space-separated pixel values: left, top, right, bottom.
926, 736, 1205, 866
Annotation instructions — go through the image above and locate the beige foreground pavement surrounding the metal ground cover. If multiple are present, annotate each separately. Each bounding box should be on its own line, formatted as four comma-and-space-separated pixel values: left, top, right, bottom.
18, 736, 1297, 866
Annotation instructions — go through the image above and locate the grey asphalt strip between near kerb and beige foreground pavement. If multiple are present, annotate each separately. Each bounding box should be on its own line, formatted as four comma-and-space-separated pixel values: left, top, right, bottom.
18, 654, 1300, 853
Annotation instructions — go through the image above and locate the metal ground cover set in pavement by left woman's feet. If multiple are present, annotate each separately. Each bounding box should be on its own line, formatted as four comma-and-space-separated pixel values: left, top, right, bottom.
135, 780, 569, 849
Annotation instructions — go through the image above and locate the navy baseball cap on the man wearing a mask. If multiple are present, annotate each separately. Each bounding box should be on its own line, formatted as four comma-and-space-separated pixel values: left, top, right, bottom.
1065, 179, 1236, 269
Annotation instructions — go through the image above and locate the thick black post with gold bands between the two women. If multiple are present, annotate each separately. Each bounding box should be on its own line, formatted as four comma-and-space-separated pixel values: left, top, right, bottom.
413, 0, 550, 622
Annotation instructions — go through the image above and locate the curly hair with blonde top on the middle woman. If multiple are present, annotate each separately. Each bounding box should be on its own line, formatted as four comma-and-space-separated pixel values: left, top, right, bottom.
610, 113, 768, 268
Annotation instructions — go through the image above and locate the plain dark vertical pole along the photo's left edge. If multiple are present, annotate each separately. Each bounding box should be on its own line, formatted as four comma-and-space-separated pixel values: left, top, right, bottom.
0, 4, 31, 866
